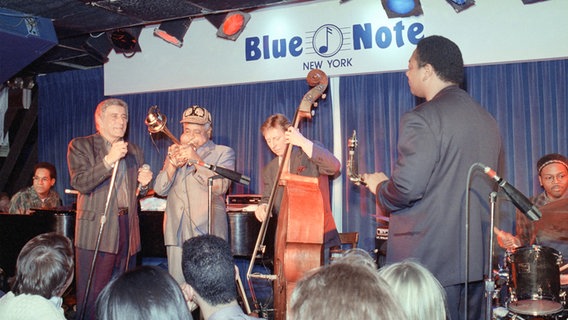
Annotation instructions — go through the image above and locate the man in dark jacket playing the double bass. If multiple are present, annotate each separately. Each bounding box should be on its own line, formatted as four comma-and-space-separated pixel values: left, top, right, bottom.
255, 114, 341, 258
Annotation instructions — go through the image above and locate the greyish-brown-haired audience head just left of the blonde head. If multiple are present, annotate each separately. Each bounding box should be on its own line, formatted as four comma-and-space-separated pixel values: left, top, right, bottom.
290, 251, 405, 320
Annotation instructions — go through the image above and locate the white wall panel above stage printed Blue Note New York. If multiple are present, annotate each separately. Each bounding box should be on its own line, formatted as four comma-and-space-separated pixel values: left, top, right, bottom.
104, 0, 568, 95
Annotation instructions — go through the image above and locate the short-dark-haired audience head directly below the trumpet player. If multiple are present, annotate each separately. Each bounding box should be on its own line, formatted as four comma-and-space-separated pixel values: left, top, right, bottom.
182, 235, 237, 306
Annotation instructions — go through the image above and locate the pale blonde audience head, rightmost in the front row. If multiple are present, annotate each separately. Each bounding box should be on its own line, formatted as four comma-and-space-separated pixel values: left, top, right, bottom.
379, 260, 446, 320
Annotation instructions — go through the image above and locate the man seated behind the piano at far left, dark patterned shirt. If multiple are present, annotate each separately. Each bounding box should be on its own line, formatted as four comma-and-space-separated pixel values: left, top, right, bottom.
9, 162, 62, 214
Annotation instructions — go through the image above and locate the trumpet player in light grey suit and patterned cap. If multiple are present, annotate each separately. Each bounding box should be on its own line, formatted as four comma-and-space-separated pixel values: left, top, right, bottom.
154, 105, 235, 284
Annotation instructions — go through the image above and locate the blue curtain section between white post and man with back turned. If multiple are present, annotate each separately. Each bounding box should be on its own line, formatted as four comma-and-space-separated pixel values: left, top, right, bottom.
340, 73, 415, 248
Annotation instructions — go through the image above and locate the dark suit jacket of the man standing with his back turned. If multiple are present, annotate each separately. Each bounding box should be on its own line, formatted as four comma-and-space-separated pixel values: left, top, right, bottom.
377, 86, 501, 286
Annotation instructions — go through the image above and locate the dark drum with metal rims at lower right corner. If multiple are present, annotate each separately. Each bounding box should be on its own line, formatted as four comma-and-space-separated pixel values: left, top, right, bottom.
507, 245, 563, 316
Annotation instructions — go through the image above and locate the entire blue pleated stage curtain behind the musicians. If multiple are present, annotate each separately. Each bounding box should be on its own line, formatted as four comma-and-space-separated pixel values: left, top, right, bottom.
38, 60, 568, 251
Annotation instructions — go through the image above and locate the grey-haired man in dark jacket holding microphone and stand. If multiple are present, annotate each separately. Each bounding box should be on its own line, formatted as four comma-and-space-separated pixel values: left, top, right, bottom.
67, 99, 152, 319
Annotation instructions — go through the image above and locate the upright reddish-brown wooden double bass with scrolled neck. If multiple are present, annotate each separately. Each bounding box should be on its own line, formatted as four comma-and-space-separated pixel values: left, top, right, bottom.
247, 69, 329, 320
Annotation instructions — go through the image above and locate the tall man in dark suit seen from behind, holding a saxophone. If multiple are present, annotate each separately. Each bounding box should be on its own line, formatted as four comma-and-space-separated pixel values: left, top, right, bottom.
363, 36, 501, 320
